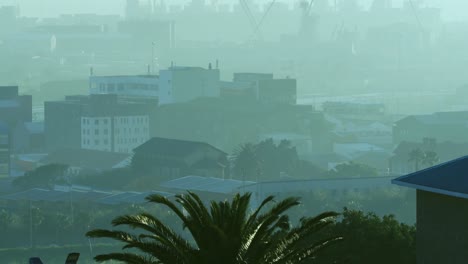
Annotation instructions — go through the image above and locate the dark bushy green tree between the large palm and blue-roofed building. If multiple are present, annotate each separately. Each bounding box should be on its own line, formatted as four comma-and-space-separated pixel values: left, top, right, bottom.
317, 208, 416, 264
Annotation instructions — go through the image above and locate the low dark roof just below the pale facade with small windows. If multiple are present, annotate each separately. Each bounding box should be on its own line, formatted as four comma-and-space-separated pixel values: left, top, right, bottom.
40, 148, 131, 169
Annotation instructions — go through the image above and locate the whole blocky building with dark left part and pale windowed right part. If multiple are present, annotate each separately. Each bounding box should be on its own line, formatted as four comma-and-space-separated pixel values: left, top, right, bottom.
45, 95, 157, 153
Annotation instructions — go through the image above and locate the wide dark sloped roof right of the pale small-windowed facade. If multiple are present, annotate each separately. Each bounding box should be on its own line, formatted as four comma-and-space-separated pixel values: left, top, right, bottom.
133, 137, 226, 156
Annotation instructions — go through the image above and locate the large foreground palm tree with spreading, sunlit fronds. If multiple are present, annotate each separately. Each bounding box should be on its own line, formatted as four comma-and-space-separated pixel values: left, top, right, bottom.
86, 192, 342, 264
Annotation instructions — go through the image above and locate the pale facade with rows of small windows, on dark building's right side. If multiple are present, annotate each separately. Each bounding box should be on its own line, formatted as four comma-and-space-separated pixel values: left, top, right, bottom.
81, 115, 150, 153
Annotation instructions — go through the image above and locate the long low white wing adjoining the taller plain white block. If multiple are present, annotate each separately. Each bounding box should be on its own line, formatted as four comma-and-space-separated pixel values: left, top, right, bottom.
89, 75, 172, 104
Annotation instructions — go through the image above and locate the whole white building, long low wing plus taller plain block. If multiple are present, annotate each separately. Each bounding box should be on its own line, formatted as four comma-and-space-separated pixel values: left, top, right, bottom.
89, 66, 220, 105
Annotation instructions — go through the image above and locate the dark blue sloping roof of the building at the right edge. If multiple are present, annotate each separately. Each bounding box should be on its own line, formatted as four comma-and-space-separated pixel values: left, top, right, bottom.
392, 156, 468, 199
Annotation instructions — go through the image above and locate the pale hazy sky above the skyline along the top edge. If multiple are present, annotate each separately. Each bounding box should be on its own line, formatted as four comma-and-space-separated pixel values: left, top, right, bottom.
0, 0, 468, 20
